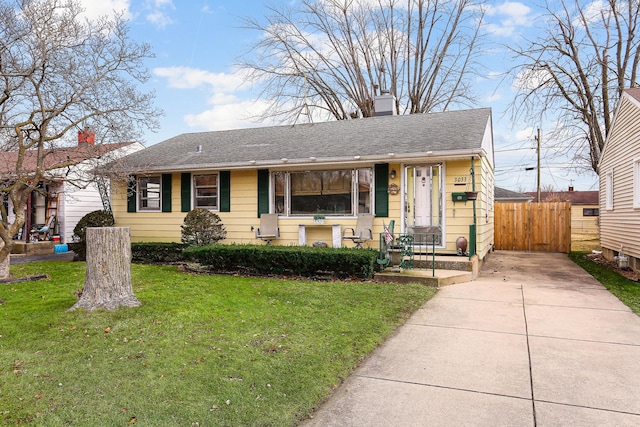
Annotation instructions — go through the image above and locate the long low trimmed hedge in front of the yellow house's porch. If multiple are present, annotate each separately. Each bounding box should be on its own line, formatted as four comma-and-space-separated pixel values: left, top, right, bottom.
183, 245, 378, 279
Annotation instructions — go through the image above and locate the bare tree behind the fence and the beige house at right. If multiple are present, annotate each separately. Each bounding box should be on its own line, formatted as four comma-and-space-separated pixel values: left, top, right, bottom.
512, 0, 640, 172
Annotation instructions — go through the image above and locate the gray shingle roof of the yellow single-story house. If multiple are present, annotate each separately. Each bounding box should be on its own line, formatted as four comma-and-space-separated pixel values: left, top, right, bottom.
126, 108, 491, 171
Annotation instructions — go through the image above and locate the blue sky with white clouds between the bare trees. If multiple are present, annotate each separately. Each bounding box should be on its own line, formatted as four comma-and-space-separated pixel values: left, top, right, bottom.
82, 0, 601, 191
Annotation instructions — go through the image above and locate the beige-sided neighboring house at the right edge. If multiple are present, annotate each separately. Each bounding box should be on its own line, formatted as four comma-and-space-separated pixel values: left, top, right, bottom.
598, 88, 640, 271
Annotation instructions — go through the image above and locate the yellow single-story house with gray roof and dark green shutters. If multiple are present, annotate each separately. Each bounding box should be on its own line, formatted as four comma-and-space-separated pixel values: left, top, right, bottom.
112, 104, 494, 259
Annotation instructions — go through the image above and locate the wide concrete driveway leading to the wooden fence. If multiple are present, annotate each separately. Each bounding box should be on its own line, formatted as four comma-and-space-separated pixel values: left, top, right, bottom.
302, 252, 640, 427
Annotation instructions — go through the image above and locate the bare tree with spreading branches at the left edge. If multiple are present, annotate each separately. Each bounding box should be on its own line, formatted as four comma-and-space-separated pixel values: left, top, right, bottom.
0, 0, 160, 278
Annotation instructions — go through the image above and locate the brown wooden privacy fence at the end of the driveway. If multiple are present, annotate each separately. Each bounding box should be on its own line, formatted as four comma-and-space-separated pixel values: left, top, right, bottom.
494, 202, 571, 253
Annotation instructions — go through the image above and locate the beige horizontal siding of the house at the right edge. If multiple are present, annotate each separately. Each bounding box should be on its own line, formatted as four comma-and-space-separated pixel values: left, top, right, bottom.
599, 96, 640, 258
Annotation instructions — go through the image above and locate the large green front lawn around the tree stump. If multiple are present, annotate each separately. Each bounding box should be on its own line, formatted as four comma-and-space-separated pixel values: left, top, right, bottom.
0, 262, 435, 426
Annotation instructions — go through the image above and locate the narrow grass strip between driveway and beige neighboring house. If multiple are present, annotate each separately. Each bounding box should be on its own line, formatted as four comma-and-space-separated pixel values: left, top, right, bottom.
569, 252, 640, 316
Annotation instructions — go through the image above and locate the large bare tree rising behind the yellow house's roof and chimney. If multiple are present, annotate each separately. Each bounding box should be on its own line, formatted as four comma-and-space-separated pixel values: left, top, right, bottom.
240, 0, 483, 122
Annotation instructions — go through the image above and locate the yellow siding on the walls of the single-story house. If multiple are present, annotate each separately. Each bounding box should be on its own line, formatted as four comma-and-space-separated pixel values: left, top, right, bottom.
112, 156, 493, 256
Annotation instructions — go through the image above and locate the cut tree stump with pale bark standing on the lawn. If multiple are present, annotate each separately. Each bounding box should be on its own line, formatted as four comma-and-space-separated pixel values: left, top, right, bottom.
70, 227, 140, 310
